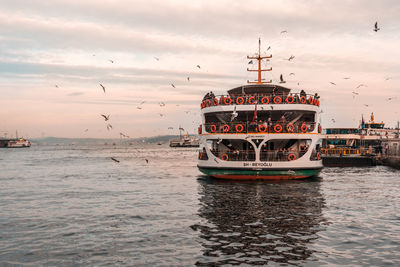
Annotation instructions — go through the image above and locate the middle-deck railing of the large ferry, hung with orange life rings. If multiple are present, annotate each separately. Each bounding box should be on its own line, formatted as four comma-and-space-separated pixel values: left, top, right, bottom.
204, 121, 316, 134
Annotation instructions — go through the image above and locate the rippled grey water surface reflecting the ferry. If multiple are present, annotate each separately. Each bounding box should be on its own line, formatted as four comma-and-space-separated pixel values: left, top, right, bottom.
0, 145, 400, 266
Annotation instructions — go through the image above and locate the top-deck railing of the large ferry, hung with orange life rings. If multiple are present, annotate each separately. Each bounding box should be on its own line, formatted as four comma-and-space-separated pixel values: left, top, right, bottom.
200, 93, 319, 109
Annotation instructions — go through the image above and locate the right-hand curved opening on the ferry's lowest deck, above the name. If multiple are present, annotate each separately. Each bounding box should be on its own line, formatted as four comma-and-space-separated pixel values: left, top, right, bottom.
260, 139, 311, 161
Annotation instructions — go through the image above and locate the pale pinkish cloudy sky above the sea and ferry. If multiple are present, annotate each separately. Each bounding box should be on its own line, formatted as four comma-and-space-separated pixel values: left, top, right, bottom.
0, 0, 400, 138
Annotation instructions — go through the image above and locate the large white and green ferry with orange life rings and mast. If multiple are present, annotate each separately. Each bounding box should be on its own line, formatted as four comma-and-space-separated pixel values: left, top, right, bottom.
198, 40, 323, 180
